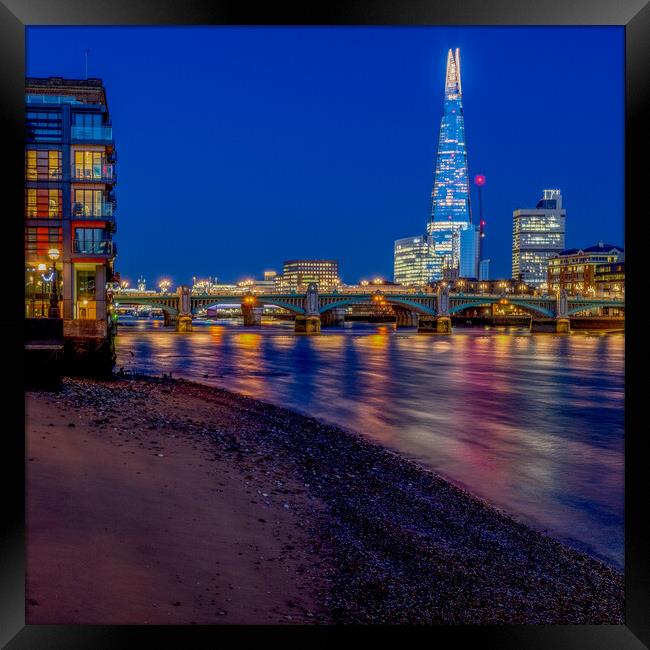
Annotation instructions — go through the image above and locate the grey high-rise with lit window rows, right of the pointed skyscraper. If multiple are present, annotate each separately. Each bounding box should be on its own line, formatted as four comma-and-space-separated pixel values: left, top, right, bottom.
512, 190, 566, 290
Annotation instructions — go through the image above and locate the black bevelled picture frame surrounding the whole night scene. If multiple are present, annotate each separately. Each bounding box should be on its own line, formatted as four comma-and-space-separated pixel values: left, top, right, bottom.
0, 0, 650, 650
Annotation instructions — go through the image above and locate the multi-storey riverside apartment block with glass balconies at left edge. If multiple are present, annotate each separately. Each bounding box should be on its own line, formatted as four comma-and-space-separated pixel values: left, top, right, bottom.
25, 77, 116, 368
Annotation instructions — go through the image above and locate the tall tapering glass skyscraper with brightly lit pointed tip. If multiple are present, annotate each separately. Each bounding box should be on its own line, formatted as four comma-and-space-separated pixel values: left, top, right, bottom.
427, 49, 479, 280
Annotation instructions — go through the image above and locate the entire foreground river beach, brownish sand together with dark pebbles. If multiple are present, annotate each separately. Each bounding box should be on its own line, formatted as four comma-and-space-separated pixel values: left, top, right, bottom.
26, 379, 624, 624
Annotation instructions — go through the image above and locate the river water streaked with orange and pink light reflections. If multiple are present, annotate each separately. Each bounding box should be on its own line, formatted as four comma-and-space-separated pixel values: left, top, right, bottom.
117, 321, 625, 569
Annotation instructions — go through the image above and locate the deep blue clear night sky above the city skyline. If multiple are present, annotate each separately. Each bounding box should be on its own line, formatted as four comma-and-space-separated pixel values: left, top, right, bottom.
27, 27, 624, 285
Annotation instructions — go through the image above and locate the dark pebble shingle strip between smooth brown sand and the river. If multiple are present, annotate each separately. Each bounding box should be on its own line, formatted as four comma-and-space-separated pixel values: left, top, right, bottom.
45, 378, 624, 624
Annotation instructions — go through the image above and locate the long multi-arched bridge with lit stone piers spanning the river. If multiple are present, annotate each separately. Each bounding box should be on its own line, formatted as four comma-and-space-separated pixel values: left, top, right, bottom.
113, 284, 625, 334
